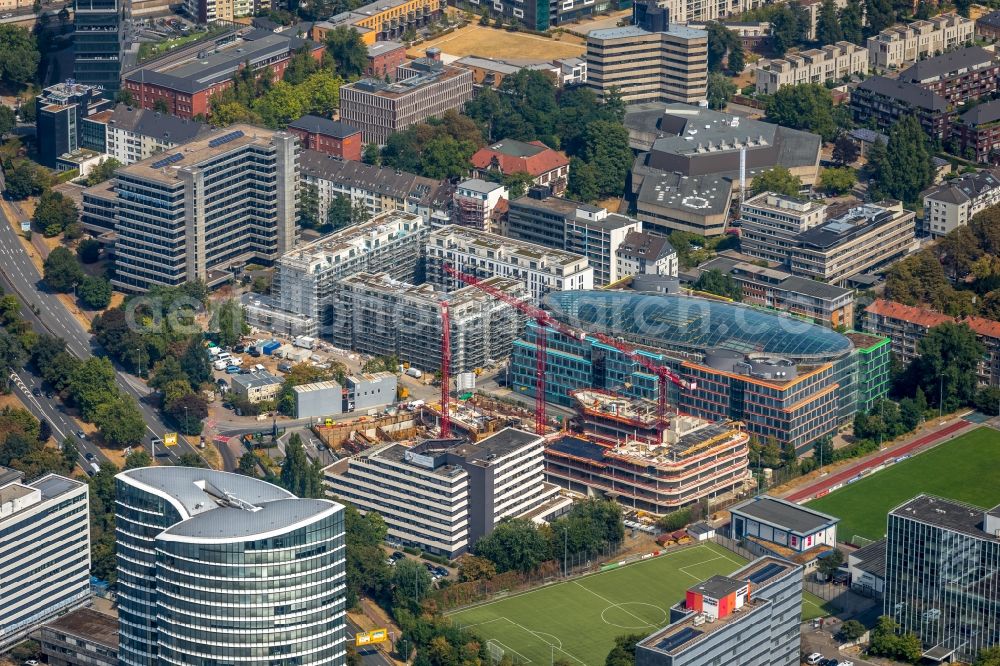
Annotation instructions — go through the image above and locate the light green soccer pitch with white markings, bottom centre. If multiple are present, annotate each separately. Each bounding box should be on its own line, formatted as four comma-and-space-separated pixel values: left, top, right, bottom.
451, 543, 746, 666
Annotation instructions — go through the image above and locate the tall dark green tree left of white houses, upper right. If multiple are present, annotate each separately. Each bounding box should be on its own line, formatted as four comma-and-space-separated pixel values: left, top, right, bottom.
868, 114, 934, 203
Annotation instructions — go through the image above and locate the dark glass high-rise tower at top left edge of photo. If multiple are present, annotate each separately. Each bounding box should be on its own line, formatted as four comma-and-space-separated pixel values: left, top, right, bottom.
73, 0, 130, 94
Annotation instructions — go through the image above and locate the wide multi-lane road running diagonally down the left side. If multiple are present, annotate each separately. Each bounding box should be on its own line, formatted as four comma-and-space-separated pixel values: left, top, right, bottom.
0, 202, 211, 462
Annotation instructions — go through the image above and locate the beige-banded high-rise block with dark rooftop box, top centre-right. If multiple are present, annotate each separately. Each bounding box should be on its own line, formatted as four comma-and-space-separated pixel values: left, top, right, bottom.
587, 0, 708, 104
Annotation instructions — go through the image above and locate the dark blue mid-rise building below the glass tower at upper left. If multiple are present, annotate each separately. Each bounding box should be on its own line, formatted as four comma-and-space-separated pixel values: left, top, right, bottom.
35, 82, 114, 169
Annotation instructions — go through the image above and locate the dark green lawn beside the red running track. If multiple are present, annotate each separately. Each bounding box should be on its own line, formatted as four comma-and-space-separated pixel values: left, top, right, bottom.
807, 428, 1000, 541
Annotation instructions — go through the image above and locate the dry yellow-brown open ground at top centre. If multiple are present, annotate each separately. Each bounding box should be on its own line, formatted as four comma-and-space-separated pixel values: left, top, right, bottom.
407, 25, 586, 60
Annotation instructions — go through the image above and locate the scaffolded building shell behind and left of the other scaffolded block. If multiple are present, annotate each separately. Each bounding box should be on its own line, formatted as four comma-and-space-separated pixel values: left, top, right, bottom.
266, 212, 430, 330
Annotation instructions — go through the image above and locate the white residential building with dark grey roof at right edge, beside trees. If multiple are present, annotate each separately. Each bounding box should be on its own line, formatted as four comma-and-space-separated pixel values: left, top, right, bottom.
920, 170, 1000, 238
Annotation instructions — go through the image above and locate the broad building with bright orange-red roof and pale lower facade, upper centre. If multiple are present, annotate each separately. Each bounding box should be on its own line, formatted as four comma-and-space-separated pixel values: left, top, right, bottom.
472, 139, 569, 195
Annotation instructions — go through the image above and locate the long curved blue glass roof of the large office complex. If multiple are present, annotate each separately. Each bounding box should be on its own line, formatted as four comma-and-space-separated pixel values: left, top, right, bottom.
543, 290, 852, 360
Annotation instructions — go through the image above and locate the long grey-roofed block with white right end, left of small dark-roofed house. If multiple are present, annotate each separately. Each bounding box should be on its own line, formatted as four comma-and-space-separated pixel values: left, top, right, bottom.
501, 187, 644, 286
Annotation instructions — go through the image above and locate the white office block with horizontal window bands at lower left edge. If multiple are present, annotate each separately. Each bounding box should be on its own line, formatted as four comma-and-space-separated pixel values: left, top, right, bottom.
0, 467, 90, 649
